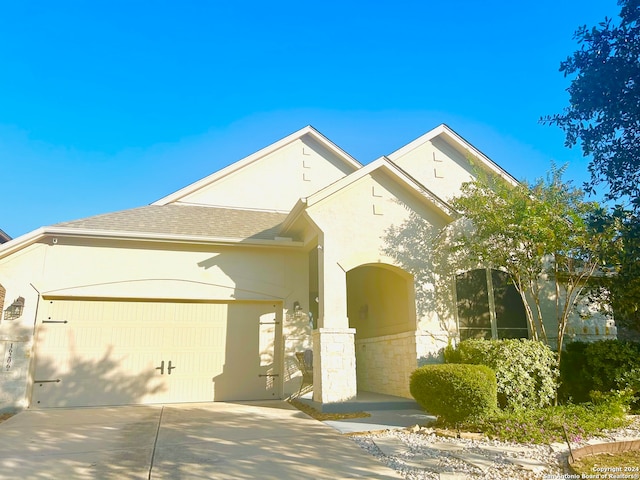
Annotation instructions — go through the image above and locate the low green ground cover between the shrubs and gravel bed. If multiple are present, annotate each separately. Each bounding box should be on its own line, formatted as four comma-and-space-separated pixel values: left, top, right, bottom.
462, 392, 630, 444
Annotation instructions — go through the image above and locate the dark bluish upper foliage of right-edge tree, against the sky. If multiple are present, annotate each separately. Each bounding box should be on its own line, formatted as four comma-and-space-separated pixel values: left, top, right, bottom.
541, 0, 640, 211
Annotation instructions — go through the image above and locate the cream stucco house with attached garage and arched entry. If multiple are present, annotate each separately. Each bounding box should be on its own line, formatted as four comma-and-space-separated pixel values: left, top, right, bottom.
0, 125, 615, 409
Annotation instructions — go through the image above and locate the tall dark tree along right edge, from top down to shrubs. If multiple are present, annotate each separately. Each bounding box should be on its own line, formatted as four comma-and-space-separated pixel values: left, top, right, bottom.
542, 0, 640, 330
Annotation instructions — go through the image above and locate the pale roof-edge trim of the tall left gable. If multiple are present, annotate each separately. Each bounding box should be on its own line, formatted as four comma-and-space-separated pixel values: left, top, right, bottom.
152, 125, 362, 205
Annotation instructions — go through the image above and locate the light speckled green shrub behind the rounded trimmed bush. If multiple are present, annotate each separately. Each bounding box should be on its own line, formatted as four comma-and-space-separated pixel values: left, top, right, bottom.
445, 339, 558, 410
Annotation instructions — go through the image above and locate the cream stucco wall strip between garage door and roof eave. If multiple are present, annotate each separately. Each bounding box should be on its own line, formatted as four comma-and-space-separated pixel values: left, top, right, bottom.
34, 238, 306, 300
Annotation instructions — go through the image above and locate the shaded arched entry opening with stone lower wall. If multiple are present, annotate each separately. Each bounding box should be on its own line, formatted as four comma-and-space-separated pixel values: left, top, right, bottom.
347, 264, 416, 396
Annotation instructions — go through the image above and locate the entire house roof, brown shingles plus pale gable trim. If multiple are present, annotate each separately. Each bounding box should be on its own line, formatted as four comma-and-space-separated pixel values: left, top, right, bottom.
0, 124, 517, 257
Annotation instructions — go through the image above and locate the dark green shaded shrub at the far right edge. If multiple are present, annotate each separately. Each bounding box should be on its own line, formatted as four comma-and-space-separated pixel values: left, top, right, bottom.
560, 340, 640, 409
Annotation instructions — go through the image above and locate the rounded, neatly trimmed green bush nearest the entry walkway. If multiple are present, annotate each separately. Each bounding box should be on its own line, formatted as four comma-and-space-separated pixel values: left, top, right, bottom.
409, 364, 497, 424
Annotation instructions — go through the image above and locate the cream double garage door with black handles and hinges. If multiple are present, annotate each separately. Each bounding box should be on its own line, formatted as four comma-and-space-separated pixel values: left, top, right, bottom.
31, 299, 281, 407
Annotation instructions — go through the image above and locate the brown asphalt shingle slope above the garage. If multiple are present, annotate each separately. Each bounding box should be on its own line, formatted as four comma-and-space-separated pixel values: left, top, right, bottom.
55, 205, 287, 240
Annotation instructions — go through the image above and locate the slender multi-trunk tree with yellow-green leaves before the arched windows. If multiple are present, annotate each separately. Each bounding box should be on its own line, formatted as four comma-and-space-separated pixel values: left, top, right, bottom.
444, 167, 613, 358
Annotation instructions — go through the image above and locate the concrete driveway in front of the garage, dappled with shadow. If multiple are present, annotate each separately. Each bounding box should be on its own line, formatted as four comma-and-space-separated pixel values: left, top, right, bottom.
0, 401, 401, 480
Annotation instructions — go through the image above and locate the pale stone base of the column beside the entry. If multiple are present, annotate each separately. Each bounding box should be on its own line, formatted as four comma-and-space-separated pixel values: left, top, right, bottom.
312, 328, 358, 404
